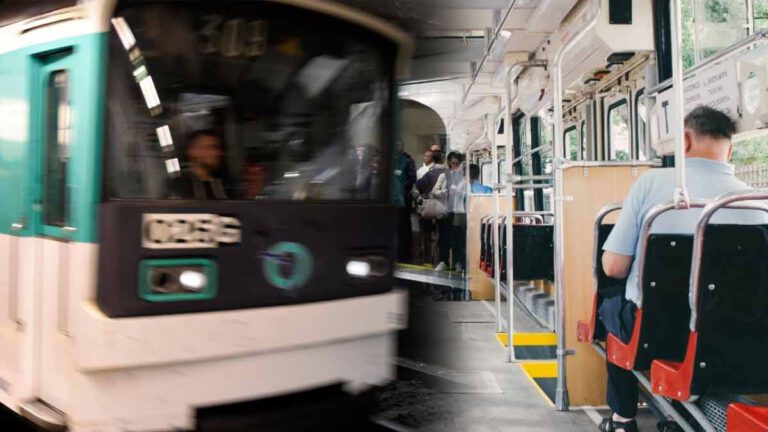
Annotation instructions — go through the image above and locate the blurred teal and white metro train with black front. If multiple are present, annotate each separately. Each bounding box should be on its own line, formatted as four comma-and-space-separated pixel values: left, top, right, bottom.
0, 0, 412, 432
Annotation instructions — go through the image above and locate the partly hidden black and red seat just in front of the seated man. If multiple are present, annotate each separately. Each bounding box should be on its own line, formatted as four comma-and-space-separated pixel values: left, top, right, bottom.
576, 218, 627, 343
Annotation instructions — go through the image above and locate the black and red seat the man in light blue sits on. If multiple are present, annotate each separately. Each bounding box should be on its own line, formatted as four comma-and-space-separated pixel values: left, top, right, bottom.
606, 234, 693, 370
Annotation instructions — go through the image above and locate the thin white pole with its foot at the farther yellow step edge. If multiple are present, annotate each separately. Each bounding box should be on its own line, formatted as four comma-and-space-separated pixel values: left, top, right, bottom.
504, 67, 515, 363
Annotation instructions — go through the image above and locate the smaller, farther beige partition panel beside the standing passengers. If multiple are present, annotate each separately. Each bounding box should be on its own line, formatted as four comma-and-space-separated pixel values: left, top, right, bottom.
467, 195, 507, 300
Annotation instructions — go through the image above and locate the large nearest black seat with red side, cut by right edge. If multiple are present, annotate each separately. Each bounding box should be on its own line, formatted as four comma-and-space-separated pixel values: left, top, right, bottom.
651, 225, 768, 401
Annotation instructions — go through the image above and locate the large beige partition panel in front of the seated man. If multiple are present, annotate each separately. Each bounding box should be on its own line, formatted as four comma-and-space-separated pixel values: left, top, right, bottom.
563, 166, 647, 406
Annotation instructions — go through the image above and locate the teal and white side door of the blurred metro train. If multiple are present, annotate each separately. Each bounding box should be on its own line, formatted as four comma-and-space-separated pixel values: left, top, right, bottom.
30, 47, 86, 406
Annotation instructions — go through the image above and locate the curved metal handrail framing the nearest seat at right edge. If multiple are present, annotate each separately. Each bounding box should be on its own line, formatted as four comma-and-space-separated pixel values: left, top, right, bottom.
688, 189, 768, 331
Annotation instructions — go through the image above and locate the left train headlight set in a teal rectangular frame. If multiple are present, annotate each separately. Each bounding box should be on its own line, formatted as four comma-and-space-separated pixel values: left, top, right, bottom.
139, 259, 218, 302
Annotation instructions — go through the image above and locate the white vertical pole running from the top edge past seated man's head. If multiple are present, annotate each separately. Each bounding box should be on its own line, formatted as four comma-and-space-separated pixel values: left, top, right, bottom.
671, 0, 690, 209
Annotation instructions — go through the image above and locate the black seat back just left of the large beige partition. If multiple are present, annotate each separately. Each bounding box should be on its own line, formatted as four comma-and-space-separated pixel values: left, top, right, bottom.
504, 225, 555, 280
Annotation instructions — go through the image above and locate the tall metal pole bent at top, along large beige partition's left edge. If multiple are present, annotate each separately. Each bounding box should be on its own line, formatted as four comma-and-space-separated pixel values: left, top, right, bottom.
552, 0, 601, 411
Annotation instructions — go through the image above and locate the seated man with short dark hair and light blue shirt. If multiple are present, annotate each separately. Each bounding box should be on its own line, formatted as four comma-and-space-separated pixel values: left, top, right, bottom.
598, 106, 762, 432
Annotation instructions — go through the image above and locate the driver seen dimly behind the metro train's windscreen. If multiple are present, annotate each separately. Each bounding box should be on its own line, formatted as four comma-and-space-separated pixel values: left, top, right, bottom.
172, 129, 227, 199
